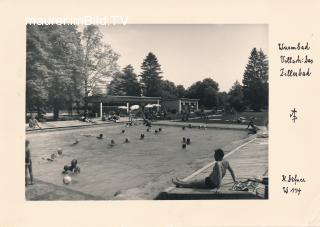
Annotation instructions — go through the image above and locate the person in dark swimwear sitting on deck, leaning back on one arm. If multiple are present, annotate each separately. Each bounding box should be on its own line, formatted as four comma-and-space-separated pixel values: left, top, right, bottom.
172, 149, 236, 189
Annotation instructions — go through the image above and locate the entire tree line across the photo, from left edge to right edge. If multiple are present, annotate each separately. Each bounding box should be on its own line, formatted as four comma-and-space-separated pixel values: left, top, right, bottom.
26, 25, 268, 119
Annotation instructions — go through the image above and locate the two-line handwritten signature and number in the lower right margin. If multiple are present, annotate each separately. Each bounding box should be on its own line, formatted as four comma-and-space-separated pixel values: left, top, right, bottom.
282, 174, 306, 196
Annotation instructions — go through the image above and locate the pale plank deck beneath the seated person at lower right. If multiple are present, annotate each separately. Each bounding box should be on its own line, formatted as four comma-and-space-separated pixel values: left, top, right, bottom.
157, 134, 268, 200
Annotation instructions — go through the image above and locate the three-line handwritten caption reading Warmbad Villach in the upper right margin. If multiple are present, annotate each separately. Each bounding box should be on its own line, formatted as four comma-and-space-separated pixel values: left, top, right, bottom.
278, 42, 314, 77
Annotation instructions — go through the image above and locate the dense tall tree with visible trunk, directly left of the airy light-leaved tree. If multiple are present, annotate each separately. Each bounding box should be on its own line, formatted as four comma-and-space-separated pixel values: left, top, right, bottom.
46, 25, 83, 120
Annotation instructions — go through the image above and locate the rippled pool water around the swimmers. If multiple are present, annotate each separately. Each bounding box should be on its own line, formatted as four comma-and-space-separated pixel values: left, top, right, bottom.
27, 124, 247, 199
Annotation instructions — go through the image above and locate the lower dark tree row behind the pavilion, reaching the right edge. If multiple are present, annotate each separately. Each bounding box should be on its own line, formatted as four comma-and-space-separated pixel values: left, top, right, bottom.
107, 48, 269, 111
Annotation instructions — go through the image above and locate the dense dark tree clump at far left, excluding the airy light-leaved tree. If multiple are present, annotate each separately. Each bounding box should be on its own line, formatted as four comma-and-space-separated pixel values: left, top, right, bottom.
26, 25, 82, 119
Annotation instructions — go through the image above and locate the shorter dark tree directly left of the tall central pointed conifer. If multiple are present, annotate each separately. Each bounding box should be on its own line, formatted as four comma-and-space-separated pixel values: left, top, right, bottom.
108, 65, 141, 96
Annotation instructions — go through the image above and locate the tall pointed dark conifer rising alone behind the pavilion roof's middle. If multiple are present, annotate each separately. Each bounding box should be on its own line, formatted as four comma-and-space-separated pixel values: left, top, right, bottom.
140, 52, 162, 96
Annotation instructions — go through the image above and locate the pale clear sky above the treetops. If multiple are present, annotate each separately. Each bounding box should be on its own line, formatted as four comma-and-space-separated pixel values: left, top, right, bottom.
100, 24, 268, 92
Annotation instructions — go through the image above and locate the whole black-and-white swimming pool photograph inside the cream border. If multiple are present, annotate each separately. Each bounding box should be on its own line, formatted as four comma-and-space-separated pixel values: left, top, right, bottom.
25, 24, 269, 201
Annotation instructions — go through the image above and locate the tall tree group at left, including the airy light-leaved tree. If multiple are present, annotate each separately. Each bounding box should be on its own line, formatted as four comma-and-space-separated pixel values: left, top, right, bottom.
26, 25, 119, 119
